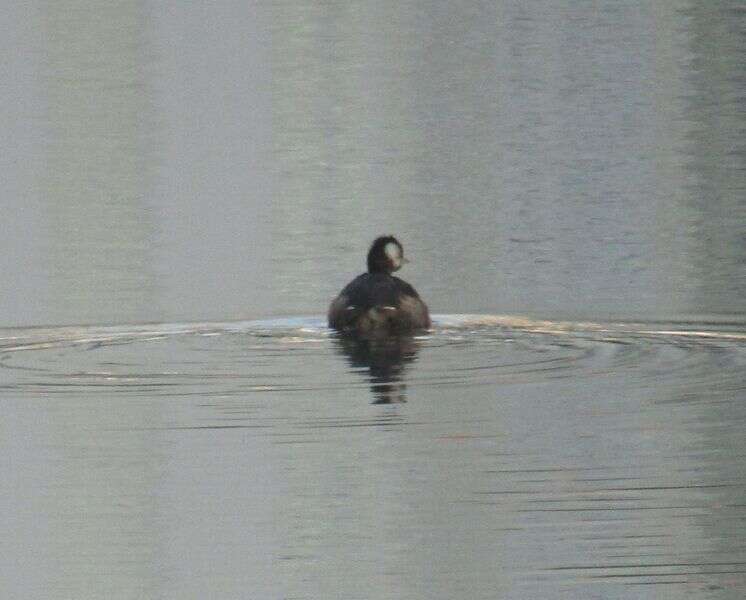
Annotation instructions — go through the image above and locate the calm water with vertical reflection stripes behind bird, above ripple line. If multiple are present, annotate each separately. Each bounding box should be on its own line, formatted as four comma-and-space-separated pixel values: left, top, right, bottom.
0, 0, 746, 325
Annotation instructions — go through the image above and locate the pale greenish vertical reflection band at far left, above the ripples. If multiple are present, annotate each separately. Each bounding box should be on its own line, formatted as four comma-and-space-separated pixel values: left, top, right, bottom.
41, 2, 161, 324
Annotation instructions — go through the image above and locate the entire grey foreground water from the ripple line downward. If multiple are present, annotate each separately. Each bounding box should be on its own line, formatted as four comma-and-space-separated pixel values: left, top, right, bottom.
0, 315, 746, 599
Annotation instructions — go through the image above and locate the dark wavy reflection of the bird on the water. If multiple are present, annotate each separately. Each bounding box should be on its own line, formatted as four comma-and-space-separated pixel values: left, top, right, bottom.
335, 335, 419, 404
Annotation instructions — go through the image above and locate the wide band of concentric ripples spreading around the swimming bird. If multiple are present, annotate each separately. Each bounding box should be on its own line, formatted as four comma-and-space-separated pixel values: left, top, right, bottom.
0, 315, 746, 395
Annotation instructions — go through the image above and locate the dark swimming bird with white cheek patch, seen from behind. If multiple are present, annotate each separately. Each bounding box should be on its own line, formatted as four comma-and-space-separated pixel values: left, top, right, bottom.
328, 235, 430, 333
